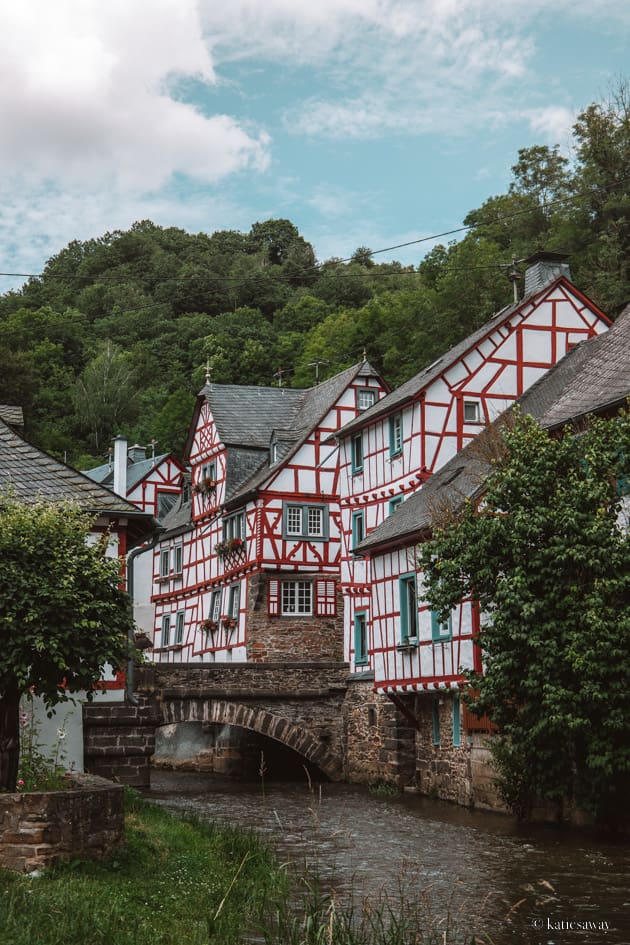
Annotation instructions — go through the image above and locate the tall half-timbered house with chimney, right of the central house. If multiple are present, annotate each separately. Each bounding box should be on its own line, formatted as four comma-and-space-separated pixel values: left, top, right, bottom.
339, 253, 610, 672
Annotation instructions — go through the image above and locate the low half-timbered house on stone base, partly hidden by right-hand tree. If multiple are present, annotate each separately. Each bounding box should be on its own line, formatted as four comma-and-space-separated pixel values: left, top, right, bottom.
350, 307, 630, 806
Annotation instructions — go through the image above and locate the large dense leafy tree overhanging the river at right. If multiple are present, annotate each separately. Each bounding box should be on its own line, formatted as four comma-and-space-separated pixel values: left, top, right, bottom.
421, 412, 630, 817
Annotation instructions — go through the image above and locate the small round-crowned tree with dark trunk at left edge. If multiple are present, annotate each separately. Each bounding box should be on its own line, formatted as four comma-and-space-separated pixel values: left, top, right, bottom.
0, 494, 133, 791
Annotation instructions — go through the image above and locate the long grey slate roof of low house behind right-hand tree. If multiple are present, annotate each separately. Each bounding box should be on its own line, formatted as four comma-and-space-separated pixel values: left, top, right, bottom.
357, 305, 630, 553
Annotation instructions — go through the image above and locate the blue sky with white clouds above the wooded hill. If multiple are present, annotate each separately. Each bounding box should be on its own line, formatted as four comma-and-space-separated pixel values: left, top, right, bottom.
0, 0, 630, 293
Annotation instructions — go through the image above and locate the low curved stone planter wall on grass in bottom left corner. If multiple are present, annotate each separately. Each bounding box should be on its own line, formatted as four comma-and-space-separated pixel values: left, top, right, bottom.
0, 775, 124, 873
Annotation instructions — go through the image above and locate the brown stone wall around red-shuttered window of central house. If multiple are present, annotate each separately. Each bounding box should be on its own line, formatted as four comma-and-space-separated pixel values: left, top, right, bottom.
246, 572, 343, 663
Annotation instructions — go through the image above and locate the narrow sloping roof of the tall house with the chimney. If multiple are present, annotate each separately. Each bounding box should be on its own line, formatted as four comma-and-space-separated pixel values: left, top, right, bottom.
338, 276, 608, 436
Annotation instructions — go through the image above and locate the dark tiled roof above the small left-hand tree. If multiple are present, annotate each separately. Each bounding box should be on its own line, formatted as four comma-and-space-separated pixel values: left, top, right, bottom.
0, 420, 157, 543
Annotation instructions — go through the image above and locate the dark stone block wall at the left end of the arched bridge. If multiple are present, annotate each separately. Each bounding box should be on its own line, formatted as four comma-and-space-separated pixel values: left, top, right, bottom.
83, 702, 161, 790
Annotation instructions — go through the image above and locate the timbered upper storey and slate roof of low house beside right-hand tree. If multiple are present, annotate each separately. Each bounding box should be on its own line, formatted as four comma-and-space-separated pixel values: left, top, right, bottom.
358, 307, 630, 694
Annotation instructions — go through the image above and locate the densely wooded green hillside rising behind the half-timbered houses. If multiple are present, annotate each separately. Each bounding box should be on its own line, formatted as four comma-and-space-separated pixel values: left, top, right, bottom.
0, 83, 630, 465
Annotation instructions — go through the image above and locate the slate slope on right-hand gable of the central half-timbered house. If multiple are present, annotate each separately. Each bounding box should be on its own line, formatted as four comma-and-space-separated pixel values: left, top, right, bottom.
226, 361, 376, 505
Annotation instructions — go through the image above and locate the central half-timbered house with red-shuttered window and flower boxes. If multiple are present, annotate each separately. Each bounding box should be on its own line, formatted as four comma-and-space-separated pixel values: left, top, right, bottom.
153, 362, 385, 662
